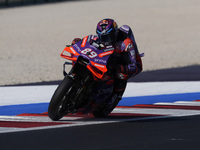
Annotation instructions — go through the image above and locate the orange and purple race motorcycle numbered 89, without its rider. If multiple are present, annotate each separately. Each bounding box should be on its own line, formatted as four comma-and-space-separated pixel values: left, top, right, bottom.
48, 36, 119, 121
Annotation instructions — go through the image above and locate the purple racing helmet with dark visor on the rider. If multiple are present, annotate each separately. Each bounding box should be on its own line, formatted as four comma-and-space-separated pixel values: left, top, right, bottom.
96, 18, 118, 45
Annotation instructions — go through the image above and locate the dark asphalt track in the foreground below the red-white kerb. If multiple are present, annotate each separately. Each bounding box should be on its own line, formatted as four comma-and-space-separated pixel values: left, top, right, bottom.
0, 116, 200, 150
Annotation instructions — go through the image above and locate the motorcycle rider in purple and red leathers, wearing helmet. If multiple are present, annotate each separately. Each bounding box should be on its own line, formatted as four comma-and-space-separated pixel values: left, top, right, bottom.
72, 19, 142, 106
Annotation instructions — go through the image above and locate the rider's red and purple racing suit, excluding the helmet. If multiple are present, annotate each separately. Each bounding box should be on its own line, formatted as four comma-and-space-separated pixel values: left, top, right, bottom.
108, 25, 142, 96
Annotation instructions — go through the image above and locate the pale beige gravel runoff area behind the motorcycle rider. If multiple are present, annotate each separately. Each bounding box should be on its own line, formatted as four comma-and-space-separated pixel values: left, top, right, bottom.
0, 0, 200, 85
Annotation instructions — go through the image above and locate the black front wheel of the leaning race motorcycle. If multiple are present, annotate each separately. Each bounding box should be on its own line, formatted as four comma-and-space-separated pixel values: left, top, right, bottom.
48, 76, 74, 121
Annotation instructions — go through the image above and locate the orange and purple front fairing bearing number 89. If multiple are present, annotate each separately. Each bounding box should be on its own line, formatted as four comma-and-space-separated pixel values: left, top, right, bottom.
60, 36, 114, 79
